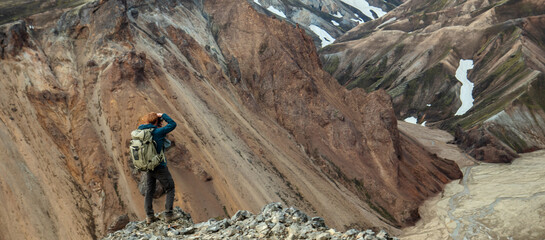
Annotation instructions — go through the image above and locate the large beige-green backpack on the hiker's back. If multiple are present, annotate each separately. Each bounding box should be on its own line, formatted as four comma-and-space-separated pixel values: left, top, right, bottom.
130, 128, 165, 171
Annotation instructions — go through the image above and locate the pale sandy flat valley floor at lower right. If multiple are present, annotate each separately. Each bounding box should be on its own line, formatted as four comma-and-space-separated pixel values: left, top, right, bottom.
400, 123, 545, 240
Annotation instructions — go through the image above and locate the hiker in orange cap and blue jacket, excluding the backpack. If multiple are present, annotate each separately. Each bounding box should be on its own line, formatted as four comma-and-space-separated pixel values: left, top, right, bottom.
138, 112, 176, 224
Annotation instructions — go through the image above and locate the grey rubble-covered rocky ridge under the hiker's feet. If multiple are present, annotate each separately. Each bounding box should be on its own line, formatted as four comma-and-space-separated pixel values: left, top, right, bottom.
102, 203, 397, 240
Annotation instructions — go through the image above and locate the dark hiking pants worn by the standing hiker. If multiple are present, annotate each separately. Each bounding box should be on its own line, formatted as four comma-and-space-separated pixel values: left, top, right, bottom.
144, 167, 174, 216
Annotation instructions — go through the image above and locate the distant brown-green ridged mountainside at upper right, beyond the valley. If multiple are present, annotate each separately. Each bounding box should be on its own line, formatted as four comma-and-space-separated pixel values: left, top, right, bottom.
321, 0, 545, 161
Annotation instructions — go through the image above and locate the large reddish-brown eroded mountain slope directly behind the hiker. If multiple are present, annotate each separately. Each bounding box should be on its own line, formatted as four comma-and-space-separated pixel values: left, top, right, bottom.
0, 0, 461, 239
